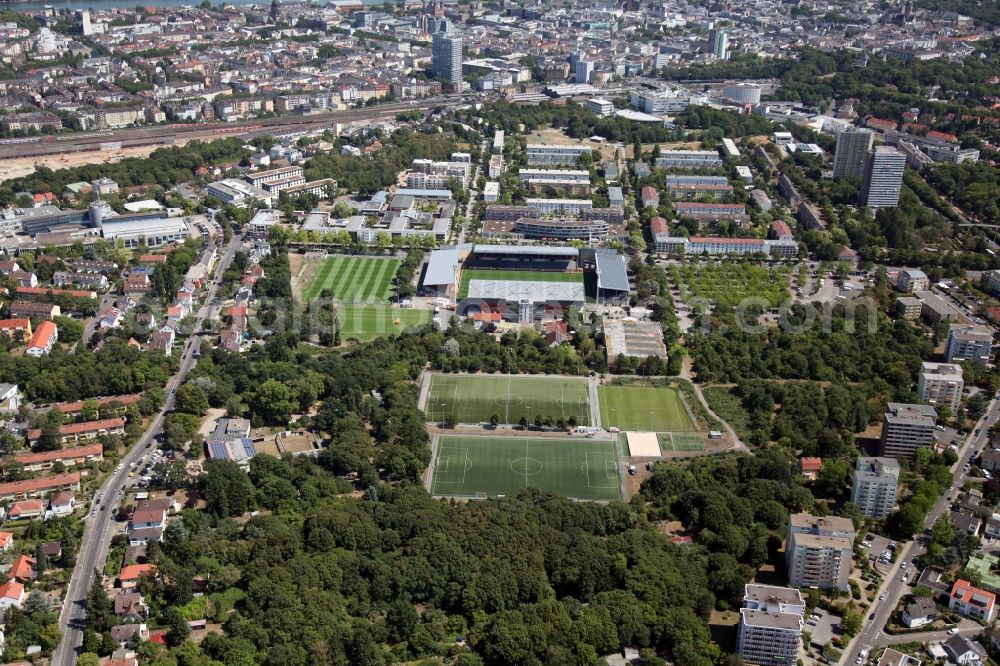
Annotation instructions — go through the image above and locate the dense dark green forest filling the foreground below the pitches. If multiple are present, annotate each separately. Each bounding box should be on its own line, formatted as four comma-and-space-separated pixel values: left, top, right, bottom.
82, 439, 828, 666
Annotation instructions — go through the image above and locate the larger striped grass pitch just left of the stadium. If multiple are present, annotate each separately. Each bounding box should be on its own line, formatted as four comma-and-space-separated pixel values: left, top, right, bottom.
303, 256, 400, 303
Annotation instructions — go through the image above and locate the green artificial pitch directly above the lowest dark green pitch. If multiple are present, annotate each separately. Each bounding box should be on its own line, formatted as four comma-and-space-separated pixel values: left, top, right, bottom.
424, 375, 590, 426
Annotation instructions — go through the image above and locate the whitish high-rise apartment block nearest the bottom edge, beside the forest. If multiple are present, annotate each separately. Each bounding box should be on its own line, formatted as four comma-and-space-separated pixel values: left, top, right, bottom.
737, 584, 805, 666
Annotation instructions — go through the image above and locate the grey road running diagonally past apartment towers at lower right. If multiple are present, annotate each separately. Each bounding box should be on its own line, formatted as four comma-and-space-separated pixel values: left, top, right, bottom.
840, 400, 1000, 664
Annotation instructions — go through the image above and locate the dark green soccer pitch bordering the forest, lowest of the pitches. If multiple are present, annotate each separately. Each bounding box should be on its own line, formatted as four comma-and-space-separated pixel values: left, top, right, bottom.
431, 436, 621, 500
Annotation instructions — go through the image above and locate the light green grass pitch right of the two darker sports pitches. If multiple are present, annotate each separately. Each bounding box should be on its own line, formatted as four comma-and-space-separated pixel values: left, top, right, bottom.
597, 386, 697, 432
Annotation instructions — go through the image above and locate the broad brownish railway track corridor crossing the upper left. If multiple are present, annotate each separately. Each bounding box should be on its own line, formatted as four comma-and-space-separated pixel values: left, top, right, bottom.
0, 95, 462, 160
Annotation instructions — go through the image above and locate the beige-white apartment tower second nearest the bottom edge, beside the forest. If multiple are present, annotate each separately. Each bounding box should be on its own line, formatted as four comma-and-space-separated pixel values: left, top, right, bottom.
785, 513, 854, 591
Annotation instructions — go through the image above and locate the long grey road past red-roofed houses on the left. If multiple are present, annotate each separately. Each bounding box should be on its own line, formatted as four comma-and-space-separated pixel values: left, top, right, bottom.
52, 237, 239, 666
